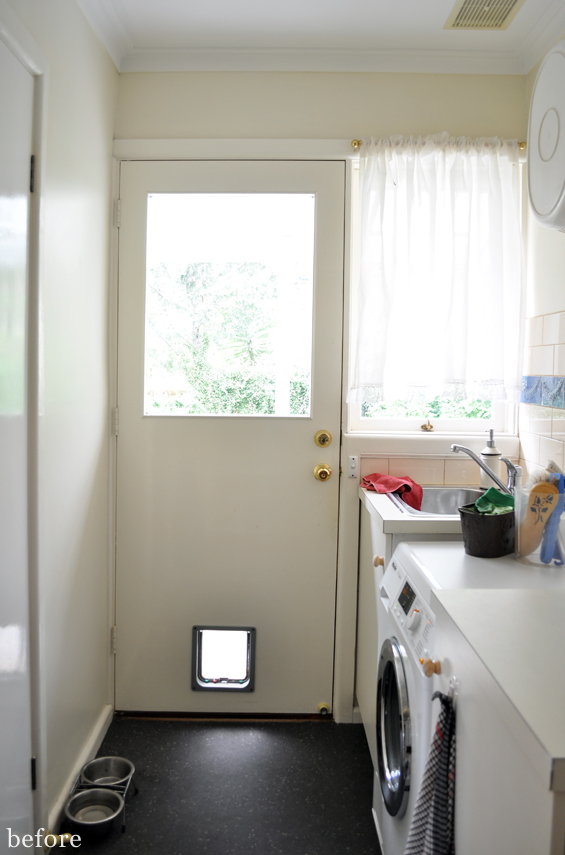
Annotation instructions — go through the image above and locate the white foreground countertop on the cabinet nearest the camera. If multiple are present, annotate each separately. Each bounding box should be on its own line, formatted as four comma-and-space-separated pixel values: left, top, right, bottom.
432, 592, 565, 791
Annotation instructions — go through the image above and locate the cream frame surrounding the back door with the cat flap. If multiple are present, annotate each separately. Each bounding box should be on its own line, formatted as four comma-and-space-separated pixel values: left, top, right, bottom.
109, 139, 360, 723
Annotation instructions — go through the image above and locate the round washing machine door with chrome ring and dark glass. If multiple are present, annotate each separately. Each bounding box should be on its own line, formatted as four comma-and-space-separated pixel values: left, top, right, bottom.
377, 638, 412, 818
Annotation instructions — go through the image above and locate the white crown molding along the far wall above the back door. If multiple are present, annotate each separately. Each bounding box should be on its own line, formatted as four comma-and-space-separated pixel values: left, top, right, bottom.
120, 48, 524, 74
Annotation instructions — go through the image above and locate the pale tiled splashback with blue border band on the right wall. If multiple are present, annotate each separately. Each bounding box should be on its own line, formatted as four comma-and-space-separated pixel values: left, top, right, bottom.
519, 312, 565, 470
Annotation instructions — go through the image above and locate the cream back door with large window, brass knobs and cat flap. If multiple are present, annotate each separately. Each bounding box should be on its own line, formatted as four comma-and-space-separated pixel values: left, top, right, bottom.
116, 161, 345, 714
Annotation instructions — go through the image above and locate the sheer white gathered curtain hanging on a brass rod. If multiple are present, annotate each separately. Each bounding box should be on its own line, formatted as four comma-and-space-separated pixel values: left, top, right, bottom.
348, 133, 523, 403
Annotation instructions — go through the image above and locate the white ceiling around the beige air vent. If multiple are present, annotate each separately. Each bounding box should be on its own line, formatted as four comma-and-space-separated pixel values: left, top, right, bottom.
77, 0, 565, 74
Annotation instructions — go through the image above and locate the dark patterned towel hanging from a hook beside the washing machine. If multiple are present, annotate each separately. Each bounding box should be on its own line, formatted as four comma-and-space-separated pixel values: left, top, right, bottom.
404, 692, 455, 855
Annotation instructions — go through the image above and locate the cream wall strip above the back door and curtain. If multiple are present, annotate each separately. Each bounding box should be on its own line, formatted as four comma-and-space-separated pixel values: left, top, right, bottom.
116, 72, 526, 139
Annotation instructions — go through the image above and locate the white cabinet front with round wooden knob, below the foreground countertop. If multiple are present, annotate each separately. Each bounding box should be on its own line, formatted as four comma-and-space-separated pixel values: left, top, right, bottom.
429, 600, 563, 855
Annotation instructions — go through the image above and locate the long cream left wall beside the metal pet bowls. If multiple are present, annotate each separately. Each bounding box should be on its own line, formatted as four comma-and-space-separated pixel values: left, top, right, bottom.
5, 0, 118, 825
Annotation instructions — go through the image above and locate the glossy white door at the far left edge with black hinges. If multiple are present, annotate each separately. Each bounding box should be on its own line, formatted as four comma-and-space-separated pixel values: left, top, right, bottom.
0, 35, 33, 851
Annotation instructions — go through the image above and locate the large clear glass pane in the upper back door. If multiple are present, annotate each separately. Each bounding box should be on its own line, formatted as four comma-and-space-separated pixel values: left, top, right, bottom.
144, 193, 315, 416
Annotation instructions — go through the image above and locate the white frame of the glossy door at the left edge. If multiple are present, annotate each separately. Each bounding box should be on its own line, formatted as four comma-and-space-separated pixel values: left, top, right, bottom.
0, 0, 49, 828
